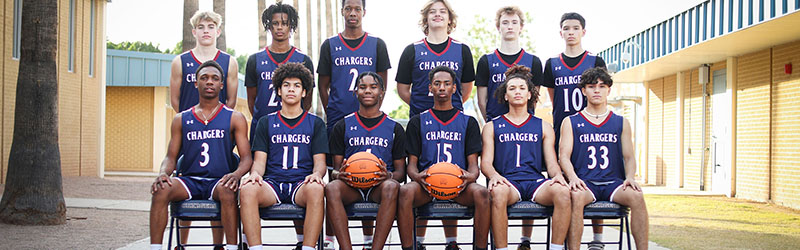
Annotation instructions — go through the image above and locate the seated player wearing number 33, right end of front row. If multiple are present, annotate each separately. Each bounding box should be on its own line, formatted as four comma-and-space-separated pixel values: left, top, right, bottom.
559, 68, 649, 250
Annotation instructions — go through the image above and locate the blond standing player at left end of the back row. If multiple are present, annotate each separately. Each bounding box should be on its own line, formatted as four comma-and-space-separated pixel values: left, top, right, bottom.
169, 10, 239, 113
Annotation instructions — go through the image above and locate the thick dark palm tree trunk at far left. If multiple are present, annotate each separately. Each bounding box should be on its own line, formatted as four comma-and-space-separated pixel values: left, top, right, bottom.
0, 0, 67, 225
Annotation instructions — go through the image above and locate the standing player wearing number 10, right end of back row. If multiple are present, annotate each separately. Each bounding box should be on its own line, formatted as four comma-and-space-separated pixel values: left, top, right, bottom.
542, 12, 606, 246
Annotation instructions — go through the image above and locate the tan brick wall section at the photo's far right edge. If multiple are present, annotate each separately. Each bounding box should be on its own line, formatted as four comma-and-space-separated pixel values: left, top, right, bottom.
771, 41, 800, 208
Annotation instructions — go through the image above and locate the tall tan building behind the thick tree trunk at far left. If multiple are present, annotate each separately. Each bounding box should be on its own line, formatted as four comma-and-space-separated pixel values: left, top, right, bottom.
0, 0, 107, 183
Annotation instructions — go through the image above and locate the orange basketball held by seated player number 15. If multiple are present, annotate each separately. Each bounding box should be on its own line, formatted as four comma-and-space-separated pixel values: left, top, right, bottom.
425, 162, 464, 200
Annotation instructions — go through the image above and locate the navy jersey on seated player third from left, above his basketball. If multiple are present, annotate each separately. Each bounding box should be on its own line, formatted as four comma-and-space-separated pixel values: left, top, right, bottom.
344, 113, 396, 172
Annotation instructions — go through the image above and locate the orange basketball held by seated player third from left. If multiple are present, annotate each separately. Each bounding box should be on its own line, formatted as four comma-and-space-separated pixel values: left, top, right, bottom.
342, 152, 383, 188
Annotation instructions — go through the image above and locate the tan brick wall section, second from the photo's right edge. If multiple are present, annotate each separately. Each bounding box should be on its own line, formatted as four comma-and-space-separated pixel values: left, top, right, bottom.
736, 49, 771, 201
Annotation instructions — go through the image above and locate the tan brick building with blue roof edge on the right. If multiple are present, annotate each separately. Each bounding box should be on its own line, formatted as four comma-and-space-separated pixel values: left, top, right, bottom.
599, 0, 800, 208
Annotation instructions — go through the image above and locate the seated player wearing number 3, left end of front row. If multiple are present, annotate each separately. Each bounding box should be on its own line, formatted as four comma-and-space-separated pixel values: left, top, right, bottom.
150, 60, 253, 250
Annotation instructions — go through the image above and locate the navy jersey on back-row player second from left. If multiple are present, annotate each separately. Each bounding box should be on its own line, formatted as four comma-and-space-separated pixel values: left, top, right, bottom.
252, 47, 306, 121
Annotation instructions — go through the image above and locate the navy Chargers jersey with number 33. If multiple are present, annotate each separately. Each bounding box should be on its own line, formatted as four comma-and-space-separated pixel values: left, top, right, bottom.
570, 112, 625, 182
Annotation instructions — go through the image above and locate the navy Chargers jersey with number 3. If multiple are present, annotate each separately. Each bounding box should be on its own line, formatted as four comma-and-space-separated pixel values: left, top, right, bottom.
178, 104, 233, 178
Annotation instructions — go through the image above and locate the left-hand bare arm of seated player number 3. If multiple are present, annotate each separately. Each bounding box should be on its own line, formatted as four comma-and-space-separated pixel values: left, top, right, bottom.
150, 113, 183, 193
